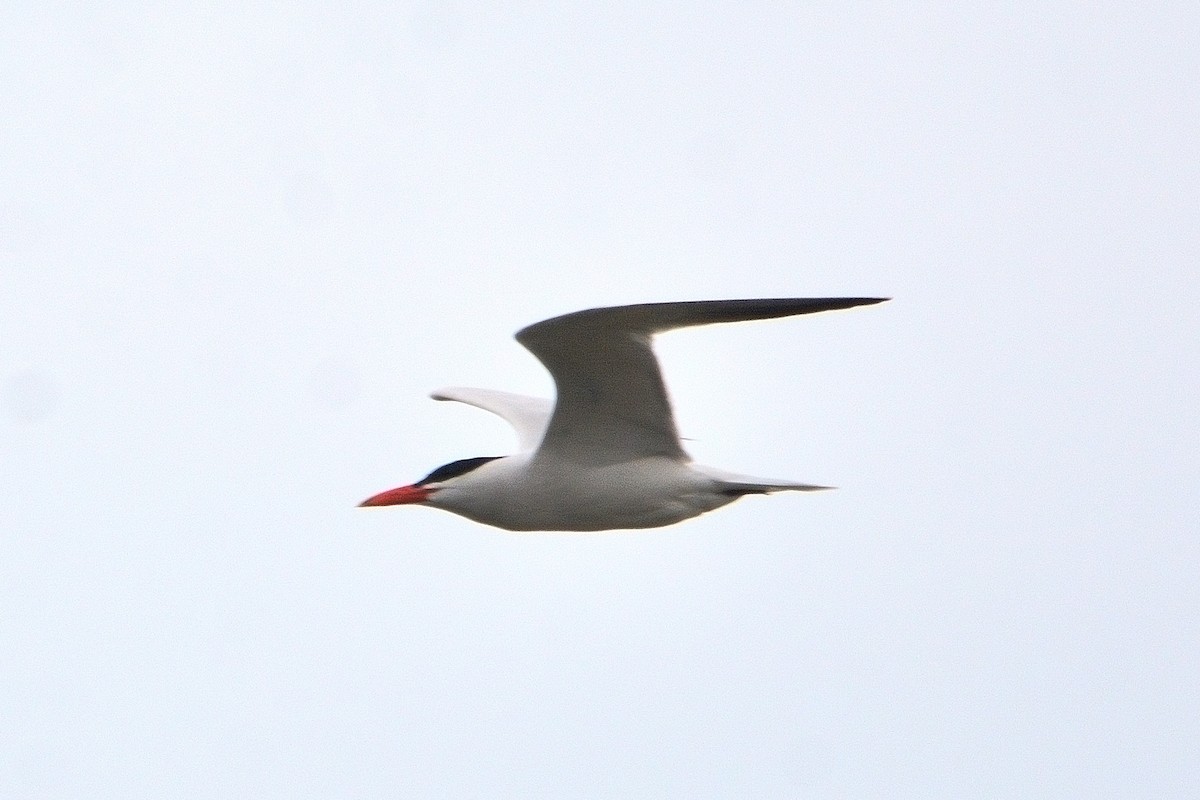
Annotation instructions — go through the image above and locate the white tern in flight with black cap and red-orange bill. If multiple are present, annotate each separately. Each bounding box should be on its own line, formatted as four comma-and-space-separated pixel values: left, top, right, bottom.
359, 297, 889, 531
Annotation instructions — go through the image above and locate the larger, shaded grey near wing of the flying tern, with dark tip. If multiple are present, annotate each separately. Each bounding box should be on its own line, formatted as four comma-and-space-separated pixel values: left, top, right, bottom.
517, 297, 884, 464
